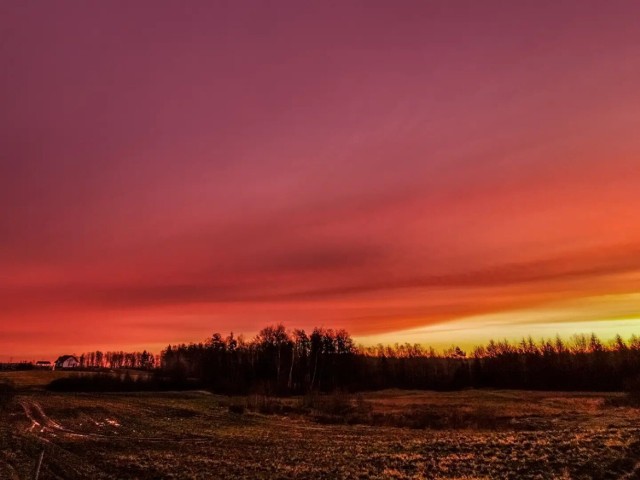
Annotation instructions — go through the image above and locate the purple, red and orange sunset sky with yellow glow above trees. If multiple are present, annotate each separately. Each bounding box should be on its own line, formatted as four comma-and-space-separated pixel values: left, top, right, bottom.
0, 0, 640, 360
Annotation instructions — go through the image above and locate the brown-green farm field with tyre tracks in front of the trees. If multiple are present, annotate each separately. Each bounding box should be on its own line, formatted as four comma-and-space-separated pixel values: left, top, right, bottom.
0, 372, 640, 480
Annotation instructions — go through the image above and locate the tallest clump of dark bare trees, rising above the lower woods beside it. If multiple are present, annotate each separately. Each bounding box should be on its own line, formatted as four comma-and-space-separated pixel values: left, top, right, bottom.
161, 325, 358, 394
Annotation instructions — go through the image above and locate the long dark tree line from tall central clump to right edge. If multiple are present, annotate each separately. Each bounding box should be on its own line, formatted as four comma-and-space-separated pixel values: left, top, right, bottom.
159, 325, 640, 394
